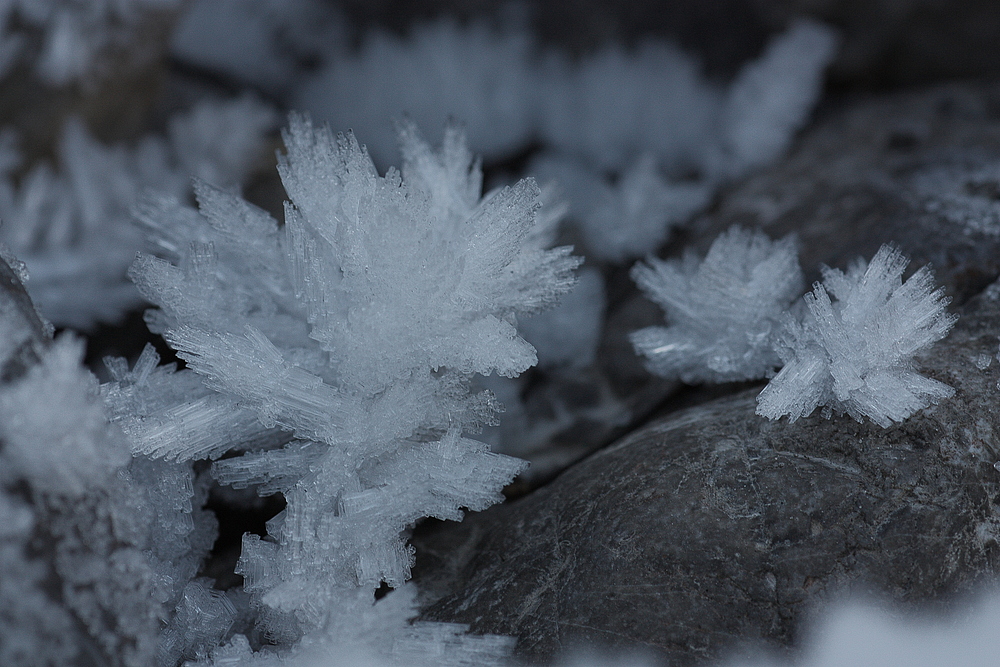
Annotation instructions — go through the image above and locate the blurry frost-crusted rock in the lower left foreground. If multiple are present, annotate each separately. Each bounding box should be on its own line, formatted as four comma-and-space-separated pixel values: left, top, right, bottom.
0, 284, 218, 667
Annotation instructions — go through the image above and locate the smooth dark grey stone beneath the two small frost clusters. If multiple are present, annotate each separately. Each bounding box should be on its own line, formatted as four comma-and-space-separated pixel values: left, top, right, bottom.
414, 274, 1000, 667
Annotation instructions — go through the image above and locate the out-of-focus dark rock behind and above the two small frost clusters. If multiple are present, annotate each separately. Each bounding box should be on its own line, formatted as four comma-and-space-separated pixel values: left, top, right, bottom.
686, 78, 1000, 303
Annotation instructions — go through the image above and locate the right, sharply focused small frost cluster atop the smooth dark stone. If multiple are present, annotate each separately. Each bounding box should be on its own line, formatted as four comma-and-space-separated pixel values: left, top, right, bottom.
757, 245, 957, 427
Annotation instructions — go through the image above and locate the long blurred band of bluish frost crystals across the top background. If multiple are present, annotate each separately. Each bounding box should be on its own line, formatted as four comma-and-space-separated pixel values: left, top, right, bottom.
293, 21, 836, 262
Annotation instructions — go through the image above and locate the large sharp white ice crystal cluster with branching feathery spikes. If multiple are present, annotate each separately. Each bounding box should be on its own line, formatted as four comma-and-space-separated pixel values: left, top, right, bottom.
106, 115, 579, 664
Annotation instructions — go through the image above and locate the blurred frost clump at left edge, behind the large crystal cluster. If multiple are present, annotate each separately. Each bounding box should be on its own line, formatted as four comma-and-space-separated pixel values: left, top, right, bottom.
0, 97, 275, 328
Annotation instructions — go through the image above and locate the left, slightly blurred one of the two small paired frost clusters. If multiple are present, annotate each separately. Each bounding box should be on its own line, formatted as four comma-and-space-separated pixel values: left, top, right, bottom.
631, 227, 803, 384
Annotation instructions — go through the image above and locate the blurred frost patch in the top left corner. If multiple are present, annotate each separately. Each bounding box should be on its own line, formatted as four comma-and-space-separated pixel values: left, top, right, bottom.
0, 0, 181, 86
